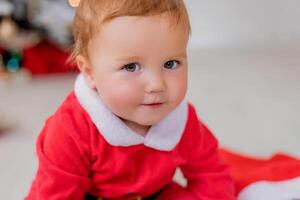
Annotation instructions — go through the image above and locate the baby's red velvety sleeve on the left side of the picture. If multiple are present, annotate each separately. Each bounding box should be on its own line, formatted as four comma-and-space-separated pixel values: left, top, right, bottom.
25, 101, 91, 200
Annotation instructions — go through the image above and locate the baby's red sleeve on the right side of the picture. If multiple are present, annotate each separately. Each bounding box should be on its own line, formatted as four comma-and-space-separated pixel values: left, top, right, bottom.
181, 106, 236, 200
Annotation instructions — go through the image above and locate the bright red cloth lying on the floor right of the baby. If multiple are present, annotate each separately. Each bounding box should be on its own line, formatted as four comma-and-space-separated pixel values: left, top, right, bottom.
220, 149, 300, 193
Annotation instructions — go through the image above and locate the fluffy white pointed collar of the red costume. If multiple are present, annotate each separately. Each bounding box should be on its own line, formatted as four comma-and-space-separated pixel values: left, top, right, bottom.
75, 74, 188, 151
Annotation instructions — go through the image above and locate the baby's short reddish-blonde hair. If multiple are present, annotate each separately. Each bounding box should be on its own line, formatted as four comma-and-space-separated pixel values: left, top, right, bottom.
70, 0, 191, 61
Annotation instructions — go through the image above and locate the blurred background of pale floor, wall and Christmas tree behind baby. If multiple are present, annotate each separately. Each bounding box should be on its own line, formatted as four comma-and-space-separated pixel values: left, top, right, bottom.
0, 0, 300, 200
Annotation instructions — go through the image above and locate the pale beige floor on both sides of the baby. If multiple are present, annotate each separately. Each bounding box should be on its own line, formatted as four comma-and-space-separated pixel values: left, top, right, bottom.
0, 49, 300, 200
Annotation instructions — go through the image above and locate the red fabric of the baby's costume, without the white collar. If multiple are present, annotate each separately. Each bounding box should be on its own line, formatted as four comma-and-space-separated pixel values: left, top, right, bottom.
26, 93, 235, 200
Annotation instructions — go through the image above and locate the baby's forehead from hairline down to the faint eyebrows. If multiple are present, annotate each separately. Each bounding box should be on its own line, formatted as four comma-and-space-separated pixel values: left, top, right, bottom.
89, 16, 188, 65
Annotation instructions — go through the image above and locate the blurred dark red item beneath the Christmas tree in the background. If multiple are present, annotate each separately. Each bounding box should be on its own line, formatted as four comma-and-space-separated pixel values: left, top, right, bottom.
22, 41, 77, 74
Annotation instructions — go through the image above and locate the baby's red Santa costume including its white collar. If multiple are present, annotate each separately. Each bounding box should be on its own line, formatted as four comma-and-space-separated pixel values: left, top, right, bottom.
25, 76, 235, 200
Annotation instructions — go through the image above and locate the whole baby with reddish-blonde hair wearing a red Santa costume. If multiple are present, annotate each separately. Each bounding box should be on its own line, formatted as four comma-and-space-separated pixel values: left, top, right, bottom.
26, 0, 235, 200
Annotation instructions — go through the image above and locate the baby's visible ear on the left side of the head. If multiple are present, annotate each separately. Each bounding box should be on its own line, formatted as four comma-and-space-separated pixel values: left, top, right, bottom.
76, 54, 96, 89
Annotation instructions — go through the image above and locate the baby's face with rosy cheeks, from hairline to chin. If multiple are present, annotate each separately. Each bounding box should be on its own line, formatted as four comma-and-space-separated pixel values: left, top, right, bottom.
81, 15, 188, 130
